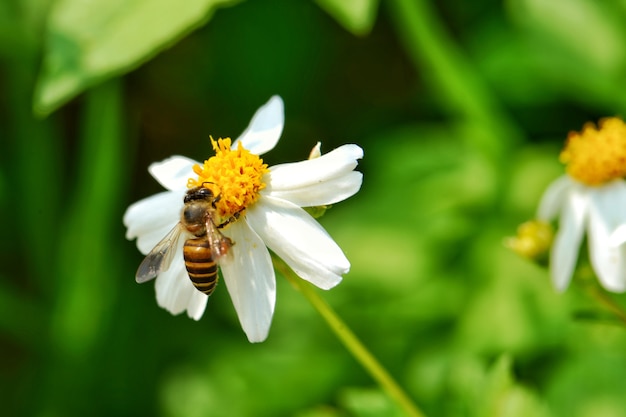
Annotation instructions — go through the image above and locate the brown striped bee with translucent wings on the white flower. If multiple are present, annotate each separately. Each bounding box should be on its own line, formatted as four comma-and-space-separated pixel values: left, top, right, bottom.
135, 185, 238, 295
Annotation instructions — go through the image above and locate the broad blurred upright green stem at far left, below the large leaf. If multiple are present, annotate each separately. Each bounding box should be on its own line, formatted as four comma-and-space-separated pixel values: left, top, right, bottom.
38, 79, 126, 416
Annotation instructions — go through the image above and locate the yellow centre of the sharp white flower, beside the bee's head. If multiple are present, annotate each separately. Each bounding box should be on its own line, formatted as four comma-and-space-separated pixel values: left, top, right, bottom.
187, 138, 269, 222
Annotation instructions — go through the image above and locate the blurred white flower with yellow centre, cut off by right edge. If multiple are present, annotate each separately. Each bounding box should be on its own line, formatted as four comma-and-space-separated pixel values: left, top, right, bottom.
537, 118, 626, 292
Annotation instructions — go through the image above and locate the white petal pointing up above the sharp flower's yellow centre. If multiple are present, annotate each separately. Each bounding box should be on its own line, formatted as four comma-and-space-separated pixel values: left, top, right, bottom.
232, 96, 285, 155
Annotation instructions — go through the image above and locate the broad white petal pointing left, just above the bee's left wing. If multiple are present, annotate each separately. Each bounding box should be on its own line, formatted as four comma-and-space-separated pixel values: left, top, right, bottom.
123, 191, 183, 255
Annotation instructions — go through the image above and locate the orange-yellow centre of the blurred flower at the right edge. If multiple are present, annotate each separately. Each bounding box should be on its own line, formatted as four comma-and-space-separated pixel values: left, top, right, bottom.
559, 117, 626, 185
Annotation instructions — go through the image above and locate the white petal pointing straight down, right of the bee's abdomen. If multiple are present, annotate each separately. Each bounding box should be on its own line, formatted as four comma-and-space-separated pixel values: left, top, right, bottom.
220, 219, 276, 343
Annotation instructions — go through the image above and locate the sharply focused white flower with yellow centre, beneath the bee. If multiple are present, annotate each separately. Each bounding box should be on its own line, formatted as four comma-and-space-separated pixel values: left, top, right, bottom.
124, 96, 363, 342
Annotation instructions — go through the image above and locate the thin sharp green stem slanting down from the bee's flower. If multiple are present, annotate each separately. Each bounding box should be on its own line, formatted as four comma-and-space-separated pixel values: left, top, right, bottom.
272, 255, 425, 417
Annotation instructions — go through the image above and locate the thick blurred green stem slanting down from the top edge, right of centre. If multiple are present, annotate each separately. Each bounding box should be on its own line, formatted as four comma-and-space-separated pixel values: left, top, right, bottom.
387, 0, 523, 176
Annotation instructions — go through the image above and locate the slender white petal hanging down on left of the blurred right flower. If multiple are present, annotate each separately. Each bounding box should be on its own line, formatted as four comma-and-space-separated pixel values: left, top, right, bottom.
550, 187, 589, 291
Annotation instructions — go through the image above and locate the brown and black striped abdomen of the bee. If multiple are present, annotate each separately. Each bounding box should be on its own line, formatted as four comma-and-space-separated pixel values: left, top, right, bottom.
183, 237, 217, 295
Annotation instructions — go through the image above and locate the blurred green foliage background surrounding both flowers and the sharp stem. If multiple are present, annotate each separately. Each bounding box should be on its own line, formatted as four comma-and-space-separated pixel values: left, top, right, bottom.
0, 0, 626, 417
